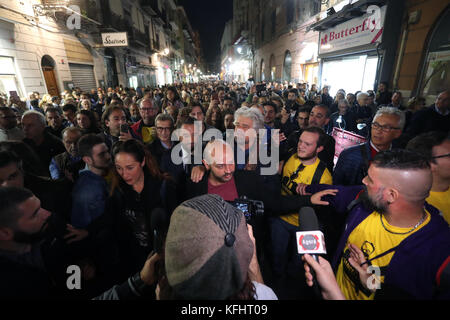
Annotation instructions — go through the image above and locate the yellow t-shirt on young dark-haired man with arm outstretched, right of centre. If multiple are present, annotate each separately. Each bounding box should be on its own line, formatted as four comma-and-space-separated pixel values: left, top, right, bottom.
281, 154, 333, 227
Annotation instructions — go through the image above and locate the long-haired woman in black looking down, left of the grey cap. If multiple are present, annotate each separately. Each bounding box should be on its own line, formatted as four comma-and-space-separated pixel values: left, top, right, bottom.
111, 139, 177, 272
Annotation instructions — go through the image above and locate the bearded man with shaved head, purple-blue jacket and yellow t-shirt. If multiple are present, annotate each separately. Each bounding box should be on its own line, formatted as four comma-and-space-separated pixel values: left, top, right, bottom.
306, 150, 450, 300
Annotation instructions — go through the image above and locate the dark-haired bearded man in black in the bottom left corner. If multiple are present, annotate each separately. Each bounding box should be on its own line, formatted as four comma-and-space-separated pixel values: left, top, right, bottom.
0, 187, 92, 299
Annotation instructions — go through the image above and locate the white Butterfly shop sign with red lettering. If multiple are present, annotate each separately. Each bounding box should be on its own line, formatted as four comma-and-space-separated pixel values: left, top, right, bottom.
319, 6, 386, 54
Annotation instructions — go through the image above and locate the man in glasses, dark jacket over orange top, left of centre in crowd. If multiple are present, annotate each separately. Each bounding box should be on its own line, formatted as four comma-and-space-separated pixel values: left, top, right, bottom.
131, 99, 159, 143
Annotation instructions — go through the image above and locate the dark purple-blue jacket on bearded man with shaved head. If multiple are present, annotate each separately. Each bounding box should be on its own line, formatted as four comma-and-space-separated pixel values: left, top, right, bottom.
306, 185, 450, 300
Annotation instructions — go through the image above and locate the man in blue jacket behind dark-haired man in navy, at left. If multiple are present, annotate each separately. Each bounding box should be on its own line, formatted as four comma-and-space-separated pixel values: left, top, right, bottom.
49, 127, 85, 182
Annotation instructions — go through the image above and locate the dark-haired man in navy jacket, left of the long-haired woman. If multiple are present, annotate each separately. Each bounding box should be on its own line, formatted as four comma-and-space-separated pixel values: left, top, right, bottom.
71, 134, 111, 229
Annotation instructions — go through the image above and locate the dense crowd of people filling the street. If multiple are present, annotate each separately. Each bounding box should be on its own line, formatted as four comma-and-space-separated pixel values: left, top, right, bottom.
0, 80, 450, 300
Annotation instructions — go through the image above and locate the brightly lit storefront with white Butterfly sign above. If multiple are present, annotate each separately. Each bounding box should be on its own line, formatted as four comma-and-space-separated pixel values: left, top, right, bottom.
319, 5, 387, 96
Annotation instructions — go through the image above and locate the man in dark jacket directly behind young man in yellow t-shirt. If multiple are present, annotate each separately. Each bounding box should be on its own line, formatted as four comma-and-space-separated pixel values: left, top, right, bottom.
280, 104, 336, 172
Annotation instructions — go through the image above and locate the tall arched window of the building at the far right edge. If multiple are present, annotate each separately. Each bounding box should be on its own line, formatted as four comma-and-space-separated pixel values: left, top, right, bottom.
419, 8, 450, 99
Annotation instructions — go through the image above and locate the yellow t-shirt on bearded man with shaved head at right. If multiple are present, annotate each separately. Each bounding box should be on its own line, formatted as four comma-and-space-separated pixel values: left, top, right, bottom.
336, 211, 431, 300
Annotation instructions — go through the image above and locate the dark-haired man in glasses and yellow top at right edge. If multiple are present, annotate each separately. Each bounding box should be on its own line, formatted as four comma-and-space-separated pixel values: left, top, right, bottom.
407, 131, 450, 224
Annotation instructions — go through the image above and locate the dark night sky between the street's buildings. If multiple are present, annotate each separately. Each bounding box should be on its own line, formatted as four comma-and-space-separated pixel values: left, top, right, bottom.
178, 0, 233, 72
